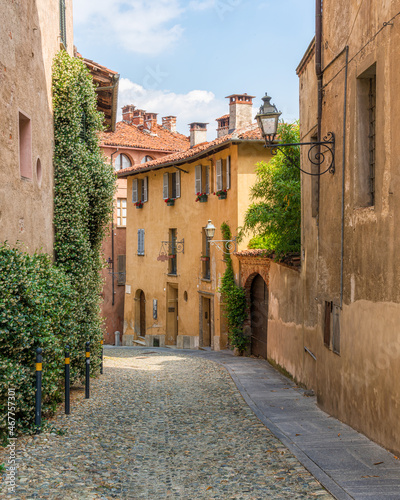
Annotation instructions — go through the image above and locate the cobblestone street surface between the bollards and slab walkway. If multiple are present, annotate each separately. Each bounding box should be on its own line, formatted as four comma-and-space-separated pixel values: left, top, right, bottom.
0, 349, 333, 500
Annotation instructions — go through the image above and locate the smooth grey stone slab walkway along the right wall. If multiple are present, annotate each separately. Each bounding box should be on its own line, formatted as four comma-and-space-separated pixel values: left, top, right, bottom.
187, 351, 400, 500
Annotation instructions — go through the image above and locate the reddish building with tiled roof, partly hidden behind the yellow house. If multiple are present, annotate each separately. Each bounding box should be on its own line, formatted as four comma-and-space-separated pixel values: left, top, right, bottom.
101, 105, 189, 344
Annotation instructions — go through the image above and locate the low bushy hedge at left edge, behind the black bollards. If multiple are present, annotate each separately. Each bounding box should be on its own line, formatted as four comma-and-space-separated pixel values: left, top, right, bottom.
0, 244, 79, 439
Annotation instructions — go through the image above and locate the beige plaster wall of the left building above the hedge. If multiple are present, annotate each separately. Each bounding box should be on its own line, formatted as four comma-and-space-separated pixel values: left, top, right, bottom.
0, 0, 73, 254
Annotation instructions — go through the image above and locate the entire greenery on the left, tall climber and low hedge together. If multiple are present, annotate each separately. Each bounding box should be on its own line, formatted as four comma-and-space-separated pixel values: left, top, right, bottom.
0, 51, 115, 442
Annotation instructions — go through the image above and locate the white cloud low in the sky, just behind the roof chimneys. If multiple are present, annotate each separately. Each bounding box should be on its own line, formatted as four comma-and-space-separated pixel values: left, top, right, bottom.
118, 78, 228, 140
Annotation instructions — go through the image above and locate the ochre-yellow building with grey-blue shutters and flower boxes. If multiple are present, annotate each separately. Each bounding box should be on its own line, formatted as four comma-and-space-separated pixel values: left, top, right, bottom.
119, 94, 269, 350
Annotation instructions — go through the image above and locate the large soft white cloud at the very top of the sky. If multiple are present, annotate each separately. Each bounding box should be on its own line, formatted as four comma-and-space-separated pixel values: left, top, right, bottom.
74, 0, 184, 55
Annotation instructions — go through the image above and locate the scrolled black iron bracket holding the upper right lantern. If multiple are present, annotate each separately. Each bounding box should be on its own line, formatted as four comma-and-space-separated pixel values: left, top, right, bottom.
266, 132, 335, 176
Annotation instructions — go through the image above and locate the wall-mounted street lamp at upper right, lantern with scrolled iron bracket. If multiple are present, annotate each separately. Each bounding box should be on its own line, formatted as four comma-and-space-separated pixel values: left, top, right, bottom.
256, 94, 335, 175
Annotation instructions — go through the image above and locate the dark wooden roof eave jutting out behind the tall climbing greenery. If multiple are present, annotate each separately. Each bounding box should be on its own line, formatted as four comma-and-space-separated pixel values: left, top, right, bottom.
78, 54, 119, 130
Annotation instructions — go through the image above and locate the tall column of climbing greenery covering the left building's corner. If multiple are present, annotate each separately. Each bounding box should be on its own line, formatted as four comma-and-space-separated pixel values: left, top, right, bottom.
53, 51, 115, 375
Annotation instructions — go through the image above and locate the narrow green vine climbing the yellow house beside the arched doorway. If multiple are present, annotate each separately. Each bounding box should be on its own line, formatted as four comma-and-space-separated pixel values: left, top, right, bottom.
219, 222, 249, 352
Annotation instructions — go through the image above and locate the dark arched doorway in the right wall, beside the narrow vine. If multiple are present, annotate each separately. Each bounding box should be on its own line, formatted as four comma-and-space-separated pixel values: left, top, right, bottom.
250, 274, 268, 359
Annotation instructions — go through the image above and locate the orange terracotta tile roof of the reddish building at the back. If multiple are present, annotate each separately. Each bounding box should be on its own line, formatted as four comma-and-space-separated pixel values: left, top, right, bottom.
101, 121, 190, 153
